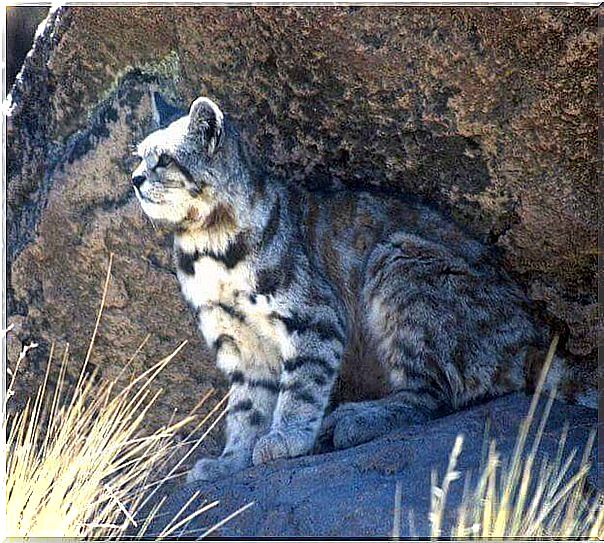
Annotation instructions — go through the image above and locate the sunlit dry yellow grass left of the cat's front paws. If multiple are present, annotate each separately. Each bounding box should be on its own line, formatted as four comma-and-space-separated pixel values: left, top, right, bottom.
3, 261, 250, 539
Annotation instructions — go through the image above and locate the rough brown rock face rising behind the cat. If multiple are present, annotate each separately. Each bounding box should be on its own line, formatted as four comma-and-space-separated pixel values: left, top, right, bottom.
7, 7, 597, 442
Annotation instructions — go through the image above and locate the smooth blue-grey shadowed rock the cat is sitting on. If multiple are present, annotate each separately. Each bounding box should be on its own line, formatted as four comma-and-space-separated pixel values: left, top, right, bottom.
149, 394, 597, 539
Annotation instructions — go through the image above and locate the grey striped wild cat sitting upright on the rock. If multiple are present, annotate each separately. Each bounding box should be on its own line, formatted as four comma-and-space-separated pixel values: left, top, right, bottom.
132, 96, 596, 480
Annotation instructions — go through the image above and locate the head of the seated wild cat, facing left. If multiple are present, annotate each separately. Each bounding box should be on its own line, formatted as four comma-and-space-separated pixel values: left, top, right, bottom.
132, 94, 230, 225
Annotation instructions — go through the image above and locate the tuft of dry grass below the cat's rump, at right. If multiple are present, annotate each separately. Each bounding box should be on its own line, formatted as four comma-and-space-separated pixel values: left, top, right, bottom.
430, 337, 604, 540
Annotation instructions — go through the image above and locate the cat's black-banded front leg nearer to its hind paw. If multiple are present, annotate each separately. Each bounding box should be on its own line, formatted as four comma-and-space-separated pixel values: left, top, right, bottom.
252, 312, 343, 465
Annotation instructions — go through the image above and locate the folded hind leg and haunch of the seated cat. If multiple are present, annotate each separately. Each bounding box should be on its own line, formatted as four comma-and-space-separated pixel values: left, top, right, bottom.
323, 233, 533, 448
